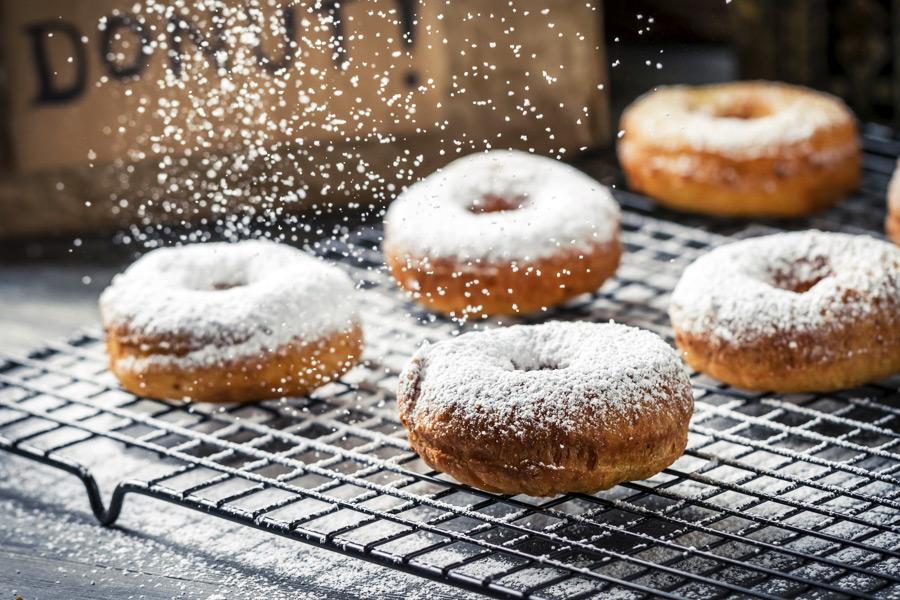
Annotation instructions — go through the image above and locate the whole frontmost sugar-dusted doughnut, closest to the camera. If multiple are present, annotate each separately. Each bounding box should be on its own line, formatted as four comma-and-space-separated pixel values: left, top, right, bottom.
397, 321, 694, 496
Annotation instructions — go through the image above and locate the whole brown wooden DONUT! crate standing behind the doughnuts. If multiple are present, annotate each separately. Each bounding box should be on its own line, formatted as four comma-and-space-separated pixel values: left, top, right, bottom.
0, 0, 609, 239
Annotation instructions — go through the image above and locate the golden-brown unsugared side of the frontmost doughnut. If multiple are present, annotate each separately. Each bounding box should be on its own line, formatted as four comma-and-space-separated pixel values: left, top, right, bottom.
398, 360, 693, 496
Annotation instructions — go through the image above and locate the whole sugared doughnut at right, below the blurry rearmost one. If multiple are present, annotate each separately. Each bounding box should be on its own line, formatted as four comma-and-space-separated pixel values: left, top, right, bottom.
669, 231, 900, 393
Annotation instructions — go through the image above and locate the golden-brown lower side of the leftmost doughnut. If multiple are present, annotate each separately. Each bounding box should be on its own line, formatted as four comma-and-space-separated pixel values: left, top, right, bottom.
106, 323, 362, 402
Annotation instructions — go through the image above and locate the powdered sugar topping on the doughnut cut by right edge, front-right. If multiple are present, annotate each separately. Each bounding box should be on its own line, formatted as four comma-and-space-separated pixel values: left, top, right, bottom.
669, 230, 900, 358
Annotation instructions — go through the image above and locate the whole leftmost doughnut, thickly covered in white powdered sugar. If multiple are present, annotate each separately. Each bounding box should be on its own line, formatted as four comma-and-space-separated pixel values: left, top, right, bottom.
100, 241, 362, 402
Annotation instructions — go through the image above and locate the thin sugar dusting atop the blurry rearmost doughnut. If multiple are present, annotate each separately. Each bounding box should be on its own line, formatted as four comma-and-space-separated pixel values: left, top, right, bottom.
625, 82, 858, 161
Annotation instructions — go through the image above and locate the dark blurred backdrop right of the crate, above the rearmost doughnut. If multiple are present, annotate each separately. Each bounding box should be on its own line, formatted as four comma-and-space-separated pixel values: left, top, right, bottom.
605, 0, 900, 127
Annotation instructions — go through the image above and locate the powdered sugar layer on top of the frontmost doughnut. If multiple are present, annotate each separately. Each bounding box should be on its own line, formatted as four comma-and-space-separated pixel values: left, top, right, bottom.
399, 321, 691, 438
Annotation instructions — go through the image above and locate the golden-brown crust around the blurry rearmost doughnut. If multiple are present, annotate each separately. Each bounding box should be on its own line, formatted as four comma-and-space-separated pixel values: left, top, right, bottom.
618, 83, 861, 217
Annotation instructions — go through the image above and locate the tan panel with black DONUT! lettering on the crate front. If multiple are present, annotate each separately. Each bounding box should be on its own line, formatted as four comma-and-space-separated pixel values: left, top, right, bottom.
3, 0, 447, 170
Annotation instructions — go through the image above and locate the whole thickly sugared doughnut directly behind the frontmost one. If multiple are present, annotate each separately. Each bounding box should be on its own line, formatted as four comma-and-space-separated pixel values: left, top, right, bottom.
383, 151, 622, 317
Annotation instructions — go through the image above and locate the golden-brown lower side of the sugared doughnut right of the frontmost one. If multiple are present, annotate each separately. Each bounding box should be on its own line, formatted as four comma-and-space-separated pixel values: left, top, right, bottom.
673, 318, 900, 393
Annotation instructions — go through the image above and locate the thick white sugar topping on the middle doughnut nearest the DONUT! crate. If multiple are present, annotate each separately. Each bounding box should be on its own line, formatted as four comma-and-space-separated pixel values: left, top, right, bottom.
385, 150, 620, 261
